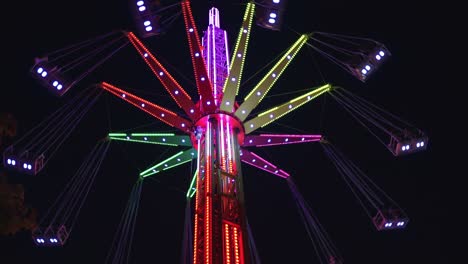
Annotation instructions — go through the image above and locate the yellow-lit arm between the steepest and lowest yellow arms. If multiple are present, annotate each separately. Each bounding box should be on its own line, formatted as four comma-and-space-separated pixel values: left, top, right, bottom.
235, 34, 309, 121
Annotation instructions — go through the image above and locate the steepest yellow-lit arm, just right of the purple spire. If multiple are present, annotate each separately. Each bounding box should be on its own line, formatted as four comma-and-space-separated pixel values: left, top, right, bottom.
221, 2, 255, 112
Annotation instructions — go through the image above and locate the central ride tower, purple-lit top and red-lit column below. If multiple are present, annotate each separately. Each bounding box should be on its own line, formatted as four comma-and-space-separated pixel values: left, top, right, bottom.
192, 8, 249, 264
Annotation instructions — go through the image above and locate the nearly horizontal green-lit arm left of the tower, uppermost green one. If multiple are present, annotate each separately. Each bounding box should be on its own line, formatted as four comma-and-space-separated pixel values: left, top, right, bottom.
108, 133, 192, 147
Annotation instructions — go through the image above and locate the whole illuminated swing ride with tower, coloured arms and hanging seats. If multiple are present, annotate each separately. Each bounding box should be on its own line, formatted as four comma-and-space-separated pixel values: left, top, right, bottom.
4, 0, 428, 264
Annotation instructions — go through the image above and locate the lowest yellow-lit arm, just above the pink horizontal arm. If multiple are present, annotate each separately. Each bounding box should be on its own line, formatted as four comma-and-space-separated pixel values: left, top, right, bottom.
244, 84, 332, 134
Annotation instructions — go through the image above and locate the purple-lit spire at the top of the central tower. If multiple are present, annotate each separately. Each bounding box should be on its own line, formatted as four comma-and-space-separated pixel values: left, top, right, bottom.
202, 7, 229, 105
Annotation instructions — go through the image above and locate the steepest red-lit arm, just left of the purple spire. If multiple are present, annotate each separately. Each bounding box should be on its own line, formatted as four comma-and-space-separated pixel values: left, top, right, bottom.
182, 1, 216, 112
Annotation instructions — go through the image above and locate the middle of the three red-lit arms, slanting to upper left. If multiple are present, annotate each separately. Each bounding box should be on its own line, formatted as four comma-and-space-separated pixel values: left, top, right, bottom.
127, 32, 200, 120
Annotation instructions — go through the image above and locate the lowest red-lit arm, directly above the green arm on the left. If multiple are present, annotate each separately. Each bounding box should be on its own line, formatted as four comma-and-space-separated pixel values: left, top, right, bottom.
101, 82, 192, 133
